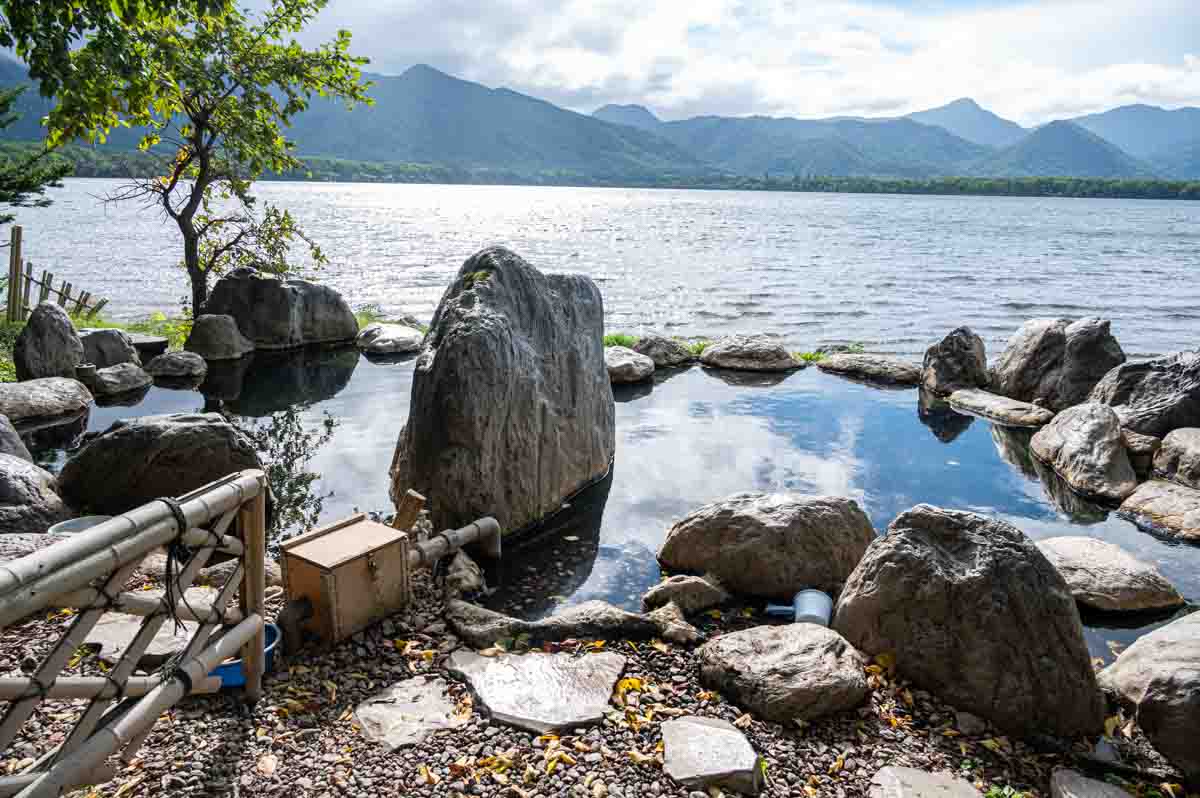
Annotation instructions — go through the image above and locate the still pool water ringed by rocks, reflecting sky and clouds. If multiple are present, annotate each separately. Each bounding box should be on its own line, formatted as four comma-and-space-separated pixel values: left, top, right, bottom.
30, 350, 1200, 659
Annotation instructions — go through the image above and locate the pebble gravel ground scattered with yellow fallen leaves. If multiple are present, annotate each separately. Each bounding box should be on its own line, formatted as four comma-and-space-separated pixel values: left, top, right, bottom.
0, 559, 1178, 798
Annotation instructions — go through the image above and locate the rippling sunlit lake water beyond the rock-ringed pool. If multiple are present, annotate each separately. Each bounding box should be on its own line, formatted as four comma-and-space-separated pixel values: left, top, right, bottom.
11, 180, 1200, 355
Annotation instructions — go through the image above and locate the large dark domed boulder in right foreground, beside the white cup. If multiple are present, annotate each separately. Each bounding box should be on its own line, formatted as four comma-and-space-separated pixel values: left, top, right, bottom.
833, 504, 1104, 736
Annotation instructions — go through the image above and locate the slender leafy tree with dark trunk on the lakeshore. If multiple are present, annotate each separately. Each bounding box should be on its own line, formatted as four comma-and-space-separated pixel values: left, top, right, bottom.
44, 0, 371, 314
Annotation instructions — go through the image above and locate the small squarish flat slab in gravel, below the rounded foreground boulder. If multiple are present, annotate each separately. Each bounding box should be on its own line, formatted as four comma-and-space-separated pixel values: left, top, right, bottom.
662, 716, 762, 794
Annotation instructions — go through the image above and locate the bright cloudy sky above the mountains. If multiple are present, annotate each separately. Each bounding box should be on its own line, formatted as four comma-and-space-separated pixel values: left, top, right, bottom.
274, 0, 1200, 125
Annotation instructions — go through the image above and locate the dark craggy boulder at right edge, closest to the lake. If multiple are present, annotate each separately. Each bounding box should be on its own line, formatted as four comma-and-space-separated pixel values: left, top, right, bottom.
1088, 352, 1200, 438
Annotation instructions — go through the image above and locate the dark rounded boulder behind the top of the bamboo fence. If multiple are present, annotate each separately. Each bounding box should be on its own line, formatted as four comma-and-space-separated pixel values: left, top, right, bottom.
59, 413, 262, 515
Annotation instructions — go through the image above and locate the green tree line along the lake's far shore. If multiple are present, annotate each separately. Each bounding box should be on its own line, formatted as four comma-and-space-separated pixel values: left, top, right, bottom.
0, 142, 1200, 200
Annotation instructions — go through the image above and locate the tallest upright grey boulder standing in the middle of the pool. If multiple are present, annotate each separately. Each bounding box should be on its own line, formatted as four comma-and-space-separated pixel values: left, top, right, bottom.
391, 247, 616, 533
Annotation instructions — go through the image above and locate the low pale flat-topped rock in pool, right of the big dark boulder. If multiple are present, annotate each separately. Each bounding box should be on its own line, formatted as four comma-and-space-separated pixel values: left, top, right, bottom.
1038, 535, 1183, 612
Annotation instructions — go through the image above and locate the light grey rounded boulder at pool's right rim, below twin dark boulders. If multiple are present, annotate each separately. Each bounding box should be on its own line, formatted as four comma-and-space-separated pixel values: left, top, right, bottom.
1030, 402, 1138, 502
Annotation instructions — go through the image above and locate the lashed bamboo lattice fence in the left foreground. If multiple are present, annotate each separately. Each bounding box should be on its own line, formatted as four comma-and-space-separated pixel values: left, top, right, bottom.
0, 470, 266, 798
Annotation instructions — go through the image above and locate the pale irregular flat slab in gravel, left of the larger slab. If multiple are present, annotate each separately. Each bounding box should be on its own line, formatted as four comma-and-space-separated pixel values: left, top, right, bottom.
354, 676, 470, 750
